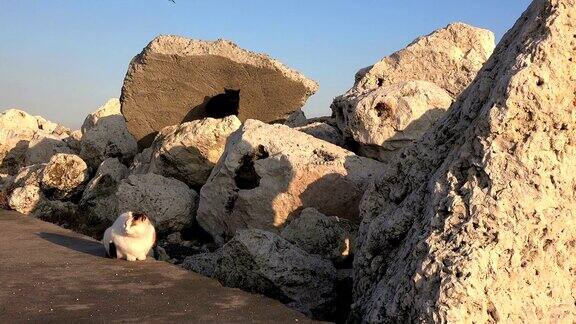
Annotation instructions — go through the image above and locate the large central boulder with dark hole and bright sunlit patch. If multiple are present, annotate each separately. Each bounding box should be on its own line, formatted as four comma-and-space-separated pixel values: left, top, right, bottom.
197, 120, 383, 244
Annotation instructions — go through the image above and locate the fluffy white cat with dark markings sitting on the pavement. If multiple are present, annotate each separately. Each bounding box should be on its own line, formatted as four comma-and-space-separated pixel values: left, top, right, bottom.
102, 212, 156, 261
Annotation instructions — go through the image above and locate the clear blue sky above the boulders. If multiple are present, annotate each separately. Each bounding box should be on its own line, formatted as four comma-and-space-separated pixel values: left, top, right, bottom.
0, 0, 530, 127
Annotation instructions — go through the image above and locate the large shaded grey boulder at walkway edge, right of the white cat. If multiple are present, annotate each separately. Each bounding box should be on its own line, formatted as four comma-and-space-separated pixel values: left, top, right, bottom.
215, 230, 336, 317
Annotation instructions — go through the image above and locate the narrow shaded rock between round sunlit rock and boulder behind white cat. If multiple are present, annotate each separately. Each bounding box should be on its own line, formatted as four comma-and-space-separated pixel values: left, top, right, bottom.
79, 158, 128, 231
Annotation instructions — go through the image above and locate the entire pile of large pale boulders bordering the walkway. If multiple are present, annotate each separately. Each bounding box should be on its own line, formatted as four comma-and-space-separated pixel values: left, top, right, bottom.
0, 0, 576, 322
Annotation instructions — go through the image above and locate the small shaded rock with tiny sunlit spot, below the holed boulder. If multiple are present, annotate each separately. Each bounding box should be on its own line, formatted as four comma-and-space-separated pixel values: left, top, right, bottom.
280, 208, 356, 260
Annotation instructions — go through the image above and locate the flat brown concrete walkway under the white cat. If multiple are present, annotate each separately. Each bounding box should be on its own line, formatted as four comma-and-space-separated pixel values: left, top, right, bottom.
0, 210, 310, 323
